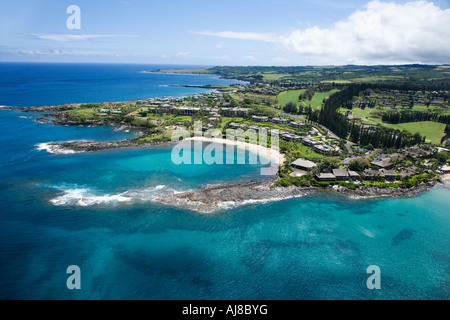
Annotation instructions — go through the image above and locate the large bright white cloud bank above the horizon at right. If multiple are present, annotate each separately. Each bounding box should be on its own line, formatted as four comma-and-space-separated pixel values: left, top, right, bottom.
192, 0, 450, 64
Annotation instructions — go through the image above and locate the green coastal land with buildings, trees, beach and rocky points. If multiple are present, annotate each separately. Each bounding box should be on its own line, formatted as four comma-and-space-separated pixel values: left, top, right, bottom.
4, 63, 450, 213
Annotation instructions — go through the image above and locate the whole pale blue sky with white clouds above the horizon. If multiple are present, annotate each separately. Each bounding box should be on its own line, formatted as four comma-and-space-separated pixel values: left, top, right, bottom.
0, 0, 450, 65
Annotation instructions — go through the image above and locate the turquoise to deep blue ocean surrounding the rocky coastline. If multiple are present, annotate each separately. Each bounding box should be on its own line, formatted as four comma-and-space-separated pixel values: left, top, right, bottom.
0, 64, 450, 299
